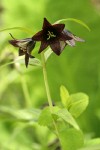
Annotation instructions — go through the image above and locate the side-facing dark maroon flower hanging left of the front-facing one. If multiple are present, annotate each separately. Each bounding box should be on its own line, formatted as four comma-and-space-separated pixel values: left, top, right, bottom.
9, 34, 36, 67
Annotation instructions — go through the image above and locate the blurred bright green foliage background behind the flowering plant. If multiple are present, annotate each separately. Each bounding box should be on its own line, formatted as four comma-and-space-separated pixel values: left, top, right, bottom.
0, 0, 100, 150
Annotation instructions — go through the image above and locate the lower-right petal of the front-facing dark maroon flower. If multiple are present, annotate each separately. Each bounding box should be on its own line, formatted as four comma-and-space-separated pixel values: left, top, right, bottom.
50, 41, 61, 55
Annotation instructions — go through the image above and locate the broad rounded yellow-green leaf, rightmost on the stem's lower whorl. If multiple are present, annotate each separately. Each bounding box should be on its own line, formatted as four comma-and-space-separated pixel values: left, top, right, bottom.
68, 93, 89, 117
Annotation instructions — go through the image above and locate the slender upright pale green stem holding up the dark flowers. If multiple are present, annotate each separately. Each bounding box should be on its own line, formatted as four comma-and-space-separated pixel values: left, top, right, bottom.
41, 52, 61, 143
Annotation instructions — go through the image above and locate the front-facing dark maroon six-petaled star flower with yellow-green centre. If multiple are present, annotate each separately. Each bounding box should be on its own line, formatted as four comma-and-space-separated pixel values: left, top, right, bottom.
32, 18, 72, 55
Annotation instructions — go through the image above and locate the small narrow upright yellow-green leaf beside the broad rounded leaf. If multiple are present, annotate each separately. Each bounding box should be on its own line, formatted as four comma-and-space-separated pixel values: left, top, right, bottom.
60, 85, 70, 108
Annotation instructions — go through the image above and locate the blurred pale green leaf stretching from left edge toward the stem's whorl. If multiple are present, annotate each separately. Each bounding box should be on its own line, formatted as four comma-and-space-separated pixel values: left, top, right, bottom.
0, 106, 41, 121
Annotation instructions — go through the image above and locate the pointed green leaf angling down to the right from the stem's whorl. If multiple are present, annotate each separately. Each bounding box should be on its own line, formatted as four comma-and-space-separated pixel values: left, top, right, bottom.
53, 109, 79, 130
